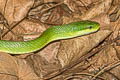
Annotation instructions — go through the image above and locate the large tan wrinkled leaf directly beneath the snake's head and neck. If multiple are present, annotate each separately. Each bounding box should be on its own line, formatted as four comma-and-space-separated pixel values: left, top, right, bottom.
57, 30, 111, 67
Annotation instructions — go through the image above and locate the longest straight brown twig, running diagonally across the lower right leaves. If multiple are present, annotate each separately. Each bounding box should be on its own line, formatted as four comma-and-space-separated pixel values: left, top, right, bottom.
44, 32, 115, 80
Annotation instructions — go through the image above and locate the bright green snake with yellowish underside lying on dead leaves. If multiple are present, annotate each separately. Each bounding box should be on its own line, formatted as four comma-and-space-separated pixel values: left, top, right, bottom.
0, 20, 100, 54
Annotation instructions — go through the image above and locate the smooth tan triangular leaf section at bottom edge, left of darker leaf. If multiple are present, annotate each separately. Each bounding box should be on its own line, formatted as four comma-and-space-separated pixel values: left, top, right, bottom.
16, 58, 40, 80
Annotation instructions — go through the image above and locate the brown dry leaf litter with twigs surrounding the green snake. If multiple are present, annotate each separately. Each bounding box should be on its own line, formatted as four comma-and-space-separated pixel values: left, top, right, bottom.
0, 0, 120, 80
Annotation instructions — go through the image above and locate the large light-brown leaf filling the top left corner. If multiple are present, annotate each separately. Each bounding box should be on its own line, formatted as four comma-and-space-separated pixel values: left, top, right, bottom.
0, 0, 34, 25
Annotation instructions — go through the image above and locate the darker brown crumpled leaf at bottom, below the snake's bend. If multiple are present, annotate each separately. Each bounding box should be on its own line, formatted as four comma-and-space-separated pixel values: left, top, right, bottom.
26, 53, 61, 78
